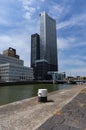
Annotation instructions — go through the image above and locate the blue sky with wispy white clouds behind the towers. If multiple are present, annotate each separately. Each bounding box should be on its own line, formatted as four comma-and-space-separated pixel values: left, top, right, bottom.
0, 0, 86, 76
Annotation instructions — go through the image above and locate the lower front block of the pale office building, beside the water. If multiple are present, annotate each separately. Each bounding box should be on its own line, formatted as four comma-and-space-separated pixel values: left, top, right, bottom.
0, 63, 34, 82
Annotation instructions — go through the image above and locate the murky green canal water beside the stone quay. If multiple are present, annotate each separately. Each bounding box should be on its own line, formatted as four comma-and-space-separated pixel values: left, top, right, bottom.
0, 84, 71, 105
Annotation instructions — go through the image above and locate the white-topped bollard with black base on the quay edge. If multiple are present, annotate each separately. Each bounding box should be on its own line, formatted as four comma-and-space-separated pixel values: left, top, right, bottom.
38, 89, 47, 102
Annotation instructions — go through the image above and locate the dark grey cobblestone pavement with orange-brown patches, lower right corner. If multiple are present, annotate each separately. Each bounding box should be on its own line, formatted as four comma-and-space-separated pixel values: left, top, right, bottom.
37, 89, 86, 130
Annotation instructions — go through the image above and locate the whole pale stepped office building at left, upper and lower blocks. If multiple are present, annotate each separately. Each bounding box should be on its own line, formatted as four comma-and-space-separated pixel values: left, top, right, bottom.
0, 50, 34, 82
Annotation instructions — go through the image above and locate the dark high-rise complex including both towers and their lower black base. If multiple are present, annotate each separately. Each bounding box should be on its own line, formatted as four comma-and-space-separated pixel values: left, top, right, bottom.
31, 12, 58, 80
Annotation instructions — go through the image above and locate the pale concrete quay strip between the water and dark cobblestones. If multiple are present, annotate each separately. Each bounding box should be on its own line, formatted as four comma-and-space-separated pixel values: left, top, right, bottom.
0, 85, 86, 130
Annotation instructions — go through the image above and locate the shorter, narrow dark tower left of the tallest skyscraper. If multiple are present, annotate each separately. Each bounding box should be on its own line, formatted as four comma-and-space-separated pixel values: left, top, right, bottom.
31, 33, 40, 67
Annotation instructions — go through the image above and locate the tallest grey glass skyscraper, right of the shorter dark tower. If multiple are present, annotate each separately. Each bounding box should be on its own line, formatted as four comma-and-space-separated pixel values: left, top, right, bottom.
40, 12, 58, 71
